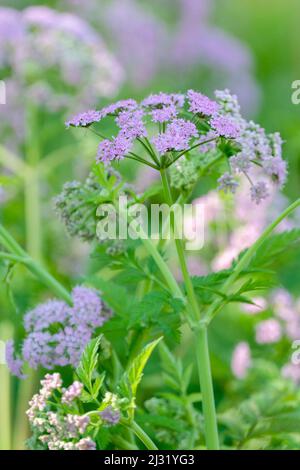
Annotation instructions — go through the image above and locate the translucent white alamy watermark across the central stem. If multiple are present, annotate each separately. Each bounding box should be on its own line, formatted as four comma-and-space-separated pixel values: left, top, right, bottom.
97, 196, 204, 251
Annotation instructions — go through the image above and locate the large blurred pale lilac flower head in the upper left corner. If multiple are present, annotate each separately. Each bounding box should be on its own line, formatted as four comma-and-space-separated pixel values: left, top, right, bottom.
0, 6, 123, 142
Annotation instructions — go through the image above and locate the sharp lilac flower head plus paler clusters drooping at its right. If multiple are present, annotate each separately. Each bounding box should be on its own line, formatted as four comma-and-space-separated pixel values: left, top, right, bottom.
67, 90, 287, 204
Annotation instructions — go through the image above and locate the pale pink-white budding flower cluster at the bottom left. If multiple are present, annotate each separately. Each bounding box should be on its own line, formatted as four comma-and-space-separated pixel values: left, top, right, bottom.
26, 373, 96, 450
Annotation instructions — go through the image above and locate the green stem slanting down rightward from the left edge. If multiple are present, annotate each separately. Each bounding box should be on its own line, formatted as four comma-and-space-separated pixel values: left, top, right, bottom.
0, 224, 72, 305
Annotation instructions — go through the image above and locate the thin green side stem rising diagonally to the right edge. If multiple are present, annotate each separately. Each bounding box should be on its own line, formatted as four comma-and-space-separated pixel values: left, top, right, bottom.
205, 198, 300, 323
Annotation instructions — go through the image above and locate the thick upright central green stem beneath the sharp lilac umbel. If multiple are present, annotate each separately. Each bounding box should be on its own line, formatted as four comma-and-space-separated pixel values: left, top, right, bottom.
160, 170, 219, 450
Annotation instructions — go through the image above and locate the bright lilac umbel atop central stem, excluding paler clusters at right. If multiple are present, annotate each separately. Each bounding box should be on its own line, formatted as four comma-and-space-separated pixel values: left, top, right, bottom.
66, 90, 234, 167
